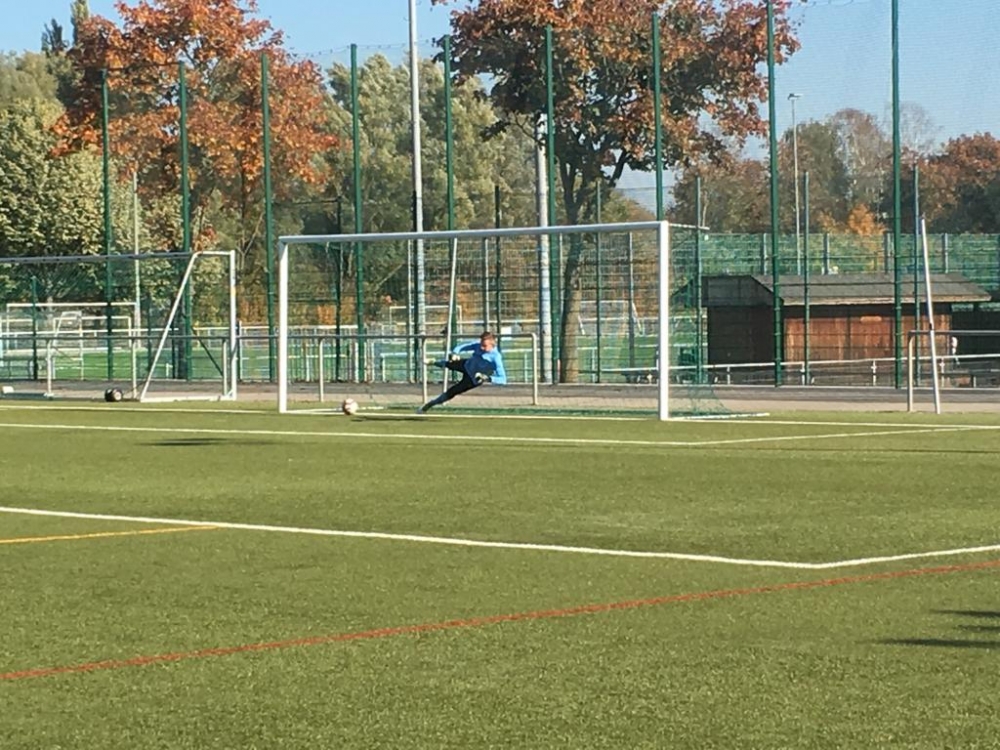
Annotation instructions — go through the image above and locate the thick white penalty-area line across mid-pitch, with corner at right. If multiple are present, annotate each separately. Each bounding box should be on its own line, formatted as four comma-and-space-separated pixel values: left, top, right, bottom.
0, 506, 1000, 570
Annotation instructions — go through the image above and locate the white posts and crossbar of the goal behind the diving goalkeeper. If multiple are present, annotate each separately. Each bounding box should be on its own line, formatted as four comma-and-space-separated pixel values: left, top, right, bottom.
277, 221, 680, 420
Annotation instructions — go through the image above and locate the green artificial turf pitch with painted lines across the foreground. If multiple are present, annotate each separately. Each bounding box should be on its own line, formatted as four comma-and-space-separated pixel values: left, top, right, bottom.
0, 404, 1000, 750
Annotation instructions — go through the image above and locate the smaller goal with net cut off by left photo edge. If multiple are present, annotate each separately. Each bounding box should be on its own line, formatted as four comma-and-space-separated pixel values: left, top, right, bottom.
0, 252, 236, 400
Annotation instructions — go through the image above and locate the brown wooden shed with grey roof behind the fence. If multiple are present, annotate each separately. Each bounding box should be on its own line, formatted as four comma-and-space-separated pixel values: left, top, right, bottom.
703, 273, 990, 365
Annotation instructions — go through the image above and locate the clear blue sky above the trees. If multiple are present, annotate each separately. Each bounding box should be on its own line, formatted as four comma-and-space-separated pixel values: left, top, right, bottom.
0, 0, 1000, 197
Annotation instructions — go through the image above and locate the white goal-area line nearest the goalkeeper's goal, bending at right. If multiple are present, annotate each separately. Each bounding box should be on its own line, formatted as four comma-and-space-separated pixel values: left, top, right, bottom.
0, 422, 973, 448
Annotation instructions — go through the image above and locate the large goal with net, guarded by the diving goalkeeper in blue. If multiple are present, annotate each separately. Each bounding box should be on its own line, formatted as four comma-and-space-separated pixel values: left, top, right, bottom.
277, 222, 725, 418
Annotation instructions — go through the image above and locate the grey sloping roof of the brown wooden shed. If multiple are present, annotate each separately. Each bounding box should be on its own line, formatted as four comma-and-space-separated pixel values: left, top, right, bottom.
705, 273, 990, 307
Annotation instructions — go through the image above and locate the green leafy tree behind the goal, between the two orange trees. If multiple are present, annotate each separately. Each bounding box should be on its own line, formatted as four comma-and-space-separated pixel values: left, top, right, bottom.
324, 55, 535, 324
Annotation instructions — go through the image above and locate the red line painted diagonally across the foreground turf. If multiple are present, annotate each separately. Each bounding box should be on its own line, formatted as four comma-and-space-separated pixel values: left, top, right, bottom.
0, 560, 1000, 681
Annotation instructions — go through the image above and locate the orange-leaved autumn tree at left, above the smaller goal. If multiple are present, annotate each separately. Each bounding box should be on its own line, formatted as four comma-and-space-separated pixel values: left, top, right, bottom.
58, 0, 336, 274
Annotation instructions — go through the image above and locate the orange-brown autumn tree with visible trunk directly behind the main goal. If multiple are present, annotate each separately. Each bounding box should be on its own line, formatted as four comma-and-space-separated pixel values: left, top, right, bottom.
433, 0, 798, 382
